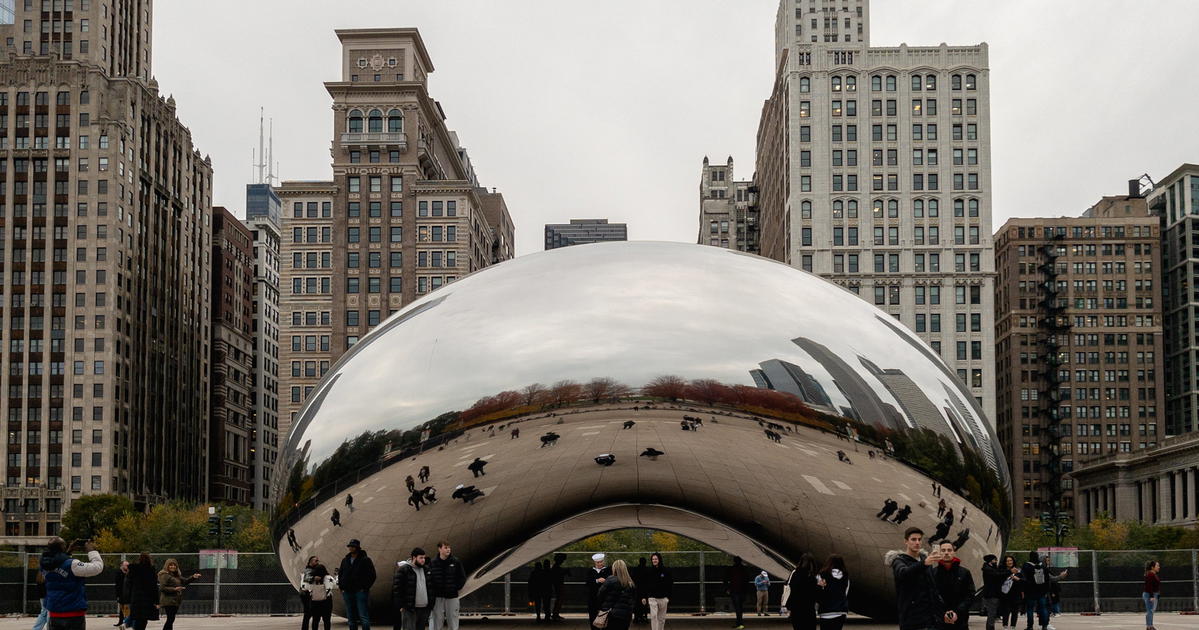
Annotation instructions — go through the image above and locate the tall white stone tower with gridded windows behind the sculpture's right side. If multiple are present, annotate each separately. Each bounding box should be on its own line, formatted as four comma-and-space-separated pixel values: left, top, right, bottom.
755, 0, 995, 424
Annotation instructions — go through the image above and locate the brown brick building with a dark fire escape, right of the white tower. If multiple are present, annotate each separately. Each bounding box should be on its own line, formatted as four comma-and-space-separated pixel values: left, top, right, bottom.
992, 208, 1164, 518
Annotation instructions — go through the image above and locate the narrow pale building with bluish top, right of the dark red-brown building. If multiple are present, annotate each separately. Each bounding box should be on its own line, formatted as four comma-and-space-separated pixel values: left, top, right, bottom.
245, 184, 281, 510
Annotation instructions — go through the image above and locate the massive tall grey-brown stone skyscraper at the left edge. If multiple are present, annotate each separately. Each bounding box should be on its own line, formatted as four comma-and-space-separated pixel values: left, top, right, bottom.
0, 0, 212, 535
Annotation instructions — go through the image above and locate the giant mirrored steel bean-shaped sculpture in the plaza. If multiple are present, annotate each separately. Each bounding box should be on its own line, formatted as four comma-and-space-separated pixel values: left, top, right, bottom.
273, 242, 1011, 617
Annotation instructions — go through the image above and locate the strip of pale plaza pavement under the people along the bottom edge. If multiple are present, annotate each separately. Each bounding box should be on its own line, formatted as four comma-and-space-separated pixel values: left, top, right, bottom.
0, 613, 1184, 630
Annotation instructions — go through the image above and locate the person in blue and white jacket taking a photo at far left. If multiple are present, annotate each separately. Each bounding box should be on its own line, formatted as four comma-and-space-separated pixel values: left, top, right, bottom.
38, 536, 104, 630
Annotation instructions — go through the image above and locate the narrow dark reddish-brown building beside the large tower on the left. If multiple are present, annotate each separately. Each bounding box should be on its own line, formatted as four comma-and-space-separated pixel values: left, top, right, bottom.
209, 208, 255, 505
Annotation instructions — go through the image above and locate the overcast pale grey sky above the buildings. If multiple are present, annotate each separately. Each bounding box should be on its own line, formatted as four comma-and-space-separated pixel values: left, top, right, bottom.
153, 0, 1199, 253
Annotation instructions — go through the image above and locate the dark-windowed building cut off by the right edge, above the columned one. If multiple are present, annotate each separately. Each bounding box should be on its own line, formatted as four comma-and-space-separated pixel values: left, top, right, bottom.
1149, 164, 1199, 436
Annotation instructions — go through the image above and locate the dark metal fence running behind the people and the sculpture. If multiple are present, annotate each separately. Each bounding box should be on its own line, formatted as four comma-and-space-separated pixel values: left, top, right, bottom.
0, 550, 1199, 614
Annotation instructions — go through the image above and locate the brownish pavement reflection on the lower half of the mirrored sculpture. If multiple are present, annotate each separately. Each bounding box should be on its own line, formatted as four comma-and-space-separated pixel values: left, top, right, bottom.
279, 407, 999, 606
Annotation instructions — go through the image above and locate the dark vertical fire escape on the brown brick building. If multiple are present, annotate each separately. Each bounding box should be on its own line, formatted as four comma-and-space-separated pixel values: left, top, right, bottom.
1037, 228, 1071, 546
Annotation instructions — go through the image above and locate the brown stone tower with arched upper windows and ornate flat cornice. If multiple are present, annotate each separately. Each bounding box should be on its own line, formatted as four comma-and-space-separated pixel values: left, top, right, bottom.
277, 29, 514, 437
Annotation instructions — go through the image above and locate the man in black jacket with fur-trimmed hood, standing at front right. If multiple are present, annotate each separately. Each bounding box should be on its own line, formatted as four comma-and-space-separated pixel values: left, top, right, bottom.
884, 527, 945, 630
